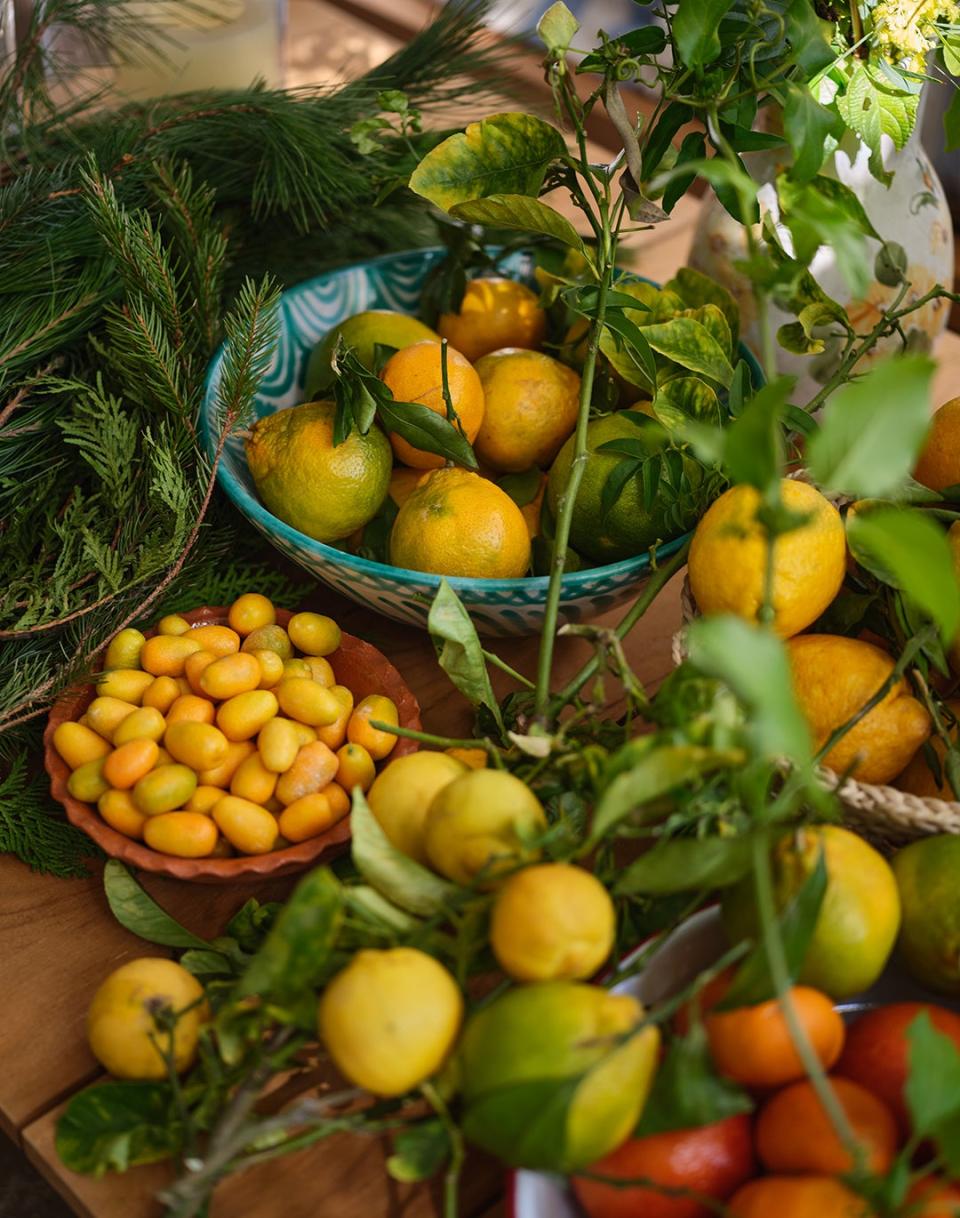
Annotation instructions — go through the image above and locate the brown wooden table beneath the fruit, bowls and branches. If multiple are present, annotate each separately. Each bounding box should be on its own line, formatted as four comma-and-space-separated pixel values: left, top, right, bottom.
9, 0, 960, 1218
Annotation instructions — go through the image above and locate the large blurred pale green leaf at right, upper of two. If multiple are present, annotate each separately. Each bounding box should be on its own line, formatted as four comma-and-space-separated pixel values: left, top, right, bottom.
806, 356, 934, 498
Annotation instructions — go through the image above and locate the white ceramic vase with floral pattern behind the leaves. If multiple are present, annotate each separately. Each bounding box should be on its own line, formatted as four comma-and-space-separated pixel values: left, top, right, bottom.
690, 120, 954, 394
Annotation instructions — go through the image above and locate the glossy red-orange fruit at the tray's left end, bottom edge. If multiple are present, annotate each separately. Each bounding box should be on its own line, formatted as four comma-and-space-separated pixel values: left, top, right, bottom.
571, 1117, 754, 1218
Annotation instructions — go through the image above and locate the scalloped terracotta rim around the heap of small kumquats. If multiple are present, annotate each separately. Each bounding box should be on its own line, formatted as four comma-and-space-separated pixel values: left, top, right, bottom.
44, 605, 422, 884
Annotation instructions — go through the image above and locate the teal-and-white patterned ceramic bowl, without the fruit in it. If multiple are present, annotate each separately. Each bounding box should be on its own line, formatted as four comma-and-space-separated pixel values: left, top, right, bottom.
201, 248, 760, 637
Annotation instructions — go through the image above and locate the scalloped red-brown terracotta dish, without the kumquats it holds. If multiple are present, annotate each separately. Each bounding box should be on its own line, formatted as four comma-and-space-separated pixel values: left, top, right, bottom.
44, 607, 420, 884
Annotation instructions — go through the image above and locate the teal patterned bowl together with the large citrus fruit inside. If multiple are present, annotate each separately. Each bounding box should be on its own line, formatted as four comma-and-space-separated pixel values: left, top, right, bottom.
201, 250, 760, 636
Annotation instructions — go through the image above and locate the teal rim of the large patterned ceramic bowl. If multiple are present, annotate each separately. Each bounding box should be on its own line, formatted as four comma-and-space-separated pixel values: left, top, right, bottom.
200, 246, 764, 603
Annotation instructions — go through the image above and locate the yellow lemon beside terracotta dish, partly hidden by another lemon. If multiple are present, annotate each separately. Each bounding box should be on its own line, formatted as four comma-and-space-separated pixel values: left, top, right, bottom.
367, 749, 467, 866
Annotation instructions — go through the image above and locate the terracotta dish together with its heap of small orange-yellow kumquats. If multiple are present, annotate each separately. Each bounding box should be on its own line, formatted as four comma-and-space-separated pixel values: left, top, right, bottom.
44, 593, 420, 883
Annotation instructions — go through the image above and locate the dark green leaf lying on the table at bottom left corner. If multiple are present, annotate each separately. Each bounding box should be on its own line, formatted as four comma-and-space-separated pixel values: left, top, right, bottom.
56, 1080, 183, 1175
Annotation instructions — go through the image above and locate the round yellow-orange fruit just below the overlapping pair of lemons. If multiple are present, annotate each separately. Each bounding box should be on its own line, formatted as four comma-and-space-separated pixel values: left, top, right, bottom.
487, 862, 615, 982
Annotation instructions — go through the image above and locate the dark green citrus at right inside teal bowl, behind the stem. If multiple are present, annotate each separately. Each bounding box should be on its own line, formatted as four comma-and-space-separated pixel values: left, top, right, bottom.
546, 410, 704, 563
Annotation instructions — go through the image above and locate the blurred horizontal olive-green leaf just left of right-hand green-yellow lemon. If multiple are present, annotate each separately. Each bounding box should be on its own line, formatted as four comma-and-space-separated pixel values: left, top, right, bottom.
614, 837, 753, 896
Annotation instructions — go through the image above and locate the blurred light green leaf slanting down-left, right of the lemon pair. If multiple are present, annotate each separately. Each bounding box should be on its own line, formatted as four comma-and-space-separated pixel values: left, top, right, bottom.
590, 744, 743, 844
